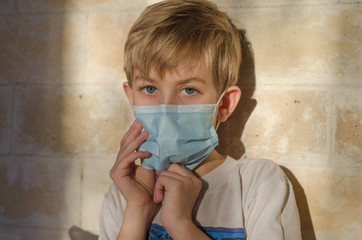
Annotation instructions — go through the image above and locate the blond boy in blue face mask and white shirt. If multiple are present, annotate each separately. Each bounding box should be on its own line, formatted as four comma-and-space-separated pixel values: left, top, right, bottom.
99, 0, 300, 240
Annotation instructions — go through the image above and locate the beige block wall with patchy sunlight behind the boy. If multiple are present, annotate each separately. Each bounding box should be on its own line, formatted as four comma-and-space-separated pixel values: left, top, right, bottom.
0, 0, 362, 240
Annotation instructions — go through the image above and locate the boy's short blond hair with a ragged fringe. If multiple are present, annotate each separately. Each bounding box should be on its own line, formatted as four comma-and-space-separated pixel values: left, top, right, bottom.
124, 0, 241, 93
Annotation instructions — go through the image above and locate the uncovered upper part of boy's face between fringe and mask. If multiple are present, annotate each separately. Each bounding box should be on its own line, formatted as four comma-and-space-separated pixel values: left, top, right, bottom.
125, 64, 218, 106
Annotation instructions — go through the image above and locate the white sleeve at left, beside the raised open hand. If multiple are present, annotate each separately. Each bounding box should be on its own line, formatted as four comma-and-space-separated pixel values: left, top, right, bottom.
98, 184, 126, 240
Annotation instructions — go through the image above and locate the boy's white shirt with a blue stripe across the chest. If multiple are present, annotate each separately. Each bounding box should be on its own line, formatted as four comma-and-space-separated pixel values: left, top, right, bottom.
99, 157, 301, 240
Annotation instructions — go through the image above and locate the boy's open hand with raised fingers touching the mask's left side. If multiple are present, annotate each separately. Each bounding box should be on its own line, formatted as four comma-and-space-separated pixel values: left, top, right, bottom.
110, 121, 155, 211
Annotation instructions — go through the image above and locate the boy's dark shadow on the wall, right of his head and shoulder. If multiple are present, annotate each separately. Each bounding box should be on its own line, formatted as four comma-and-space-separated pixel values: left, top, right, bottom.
216, 27, 316, 240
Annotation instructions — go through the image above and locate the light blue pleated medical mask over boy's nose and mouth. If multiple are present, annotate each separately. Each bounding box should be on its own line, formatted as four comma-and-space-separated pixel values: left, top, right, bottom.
133, 93, 222, 171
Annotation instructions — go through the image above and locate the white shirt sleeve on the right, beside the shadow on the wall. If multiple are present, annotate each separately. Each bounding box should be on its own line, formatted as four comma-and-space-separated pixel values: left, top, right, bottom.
244, 160, 301, 240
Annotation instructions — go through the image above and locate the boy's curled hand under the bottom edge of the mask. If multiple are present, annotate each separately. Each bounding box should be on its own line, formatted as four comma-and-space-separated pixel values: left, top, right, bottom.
154, 163, 202, 238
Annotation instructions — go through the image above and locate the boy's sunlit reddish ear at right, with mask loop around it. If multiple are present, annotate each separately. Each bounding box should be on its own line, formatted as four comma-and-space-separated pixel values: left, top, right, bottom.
216, 86, 241, 122
